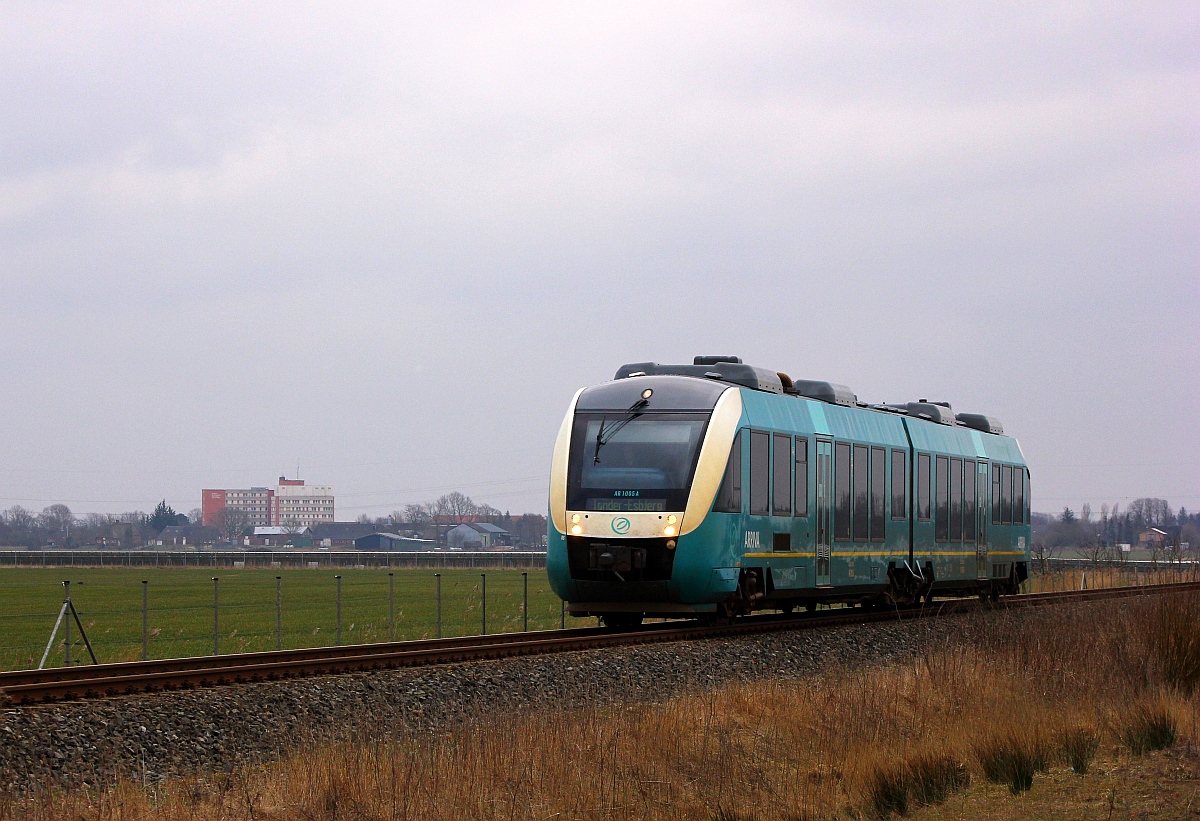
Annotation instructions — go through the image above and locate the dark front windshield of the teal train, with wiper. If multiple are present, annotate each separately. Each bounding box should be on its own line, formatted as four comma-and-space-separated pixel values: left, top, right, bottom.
566, 412, 708, 513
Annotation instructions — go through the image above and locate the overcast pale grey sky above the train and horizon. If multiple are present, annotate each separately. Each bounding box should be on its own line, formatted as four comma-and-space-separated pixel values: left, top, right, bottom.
0, 1, 1200, 520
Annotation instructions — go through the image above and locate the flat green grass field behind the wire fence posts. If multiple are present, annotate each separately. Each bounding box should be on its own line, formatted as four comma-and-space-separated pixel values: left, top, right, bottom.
0, 568, 585, 670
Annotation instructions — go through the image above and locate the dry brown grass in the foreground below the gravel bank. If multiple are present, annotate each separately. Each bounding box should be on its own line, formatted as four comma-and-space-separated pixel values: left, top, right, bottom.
7, 597, 1200, 821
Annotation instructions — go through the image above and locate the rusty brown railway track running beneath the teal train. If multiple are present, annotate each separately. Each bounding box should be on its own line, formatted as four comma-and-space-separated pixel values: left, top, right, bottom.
0, 582, 1200, 706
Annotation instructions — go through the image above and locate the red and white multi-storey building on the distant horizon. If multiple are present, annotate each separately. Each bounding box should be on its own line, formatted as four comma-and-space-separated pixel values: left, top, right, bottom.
200, 477, 334, 527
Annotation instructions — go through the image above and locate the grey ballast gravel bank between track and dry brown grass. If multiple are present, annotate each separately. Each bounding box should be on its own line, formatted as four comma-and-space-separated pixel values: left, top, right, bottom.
0, 613, 1014, 792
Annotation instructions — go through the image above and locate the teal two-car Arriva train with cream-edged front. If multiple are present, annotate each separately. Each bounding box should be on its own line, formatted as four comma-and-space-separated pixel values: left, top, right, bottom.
546, 356, 1030, 628
